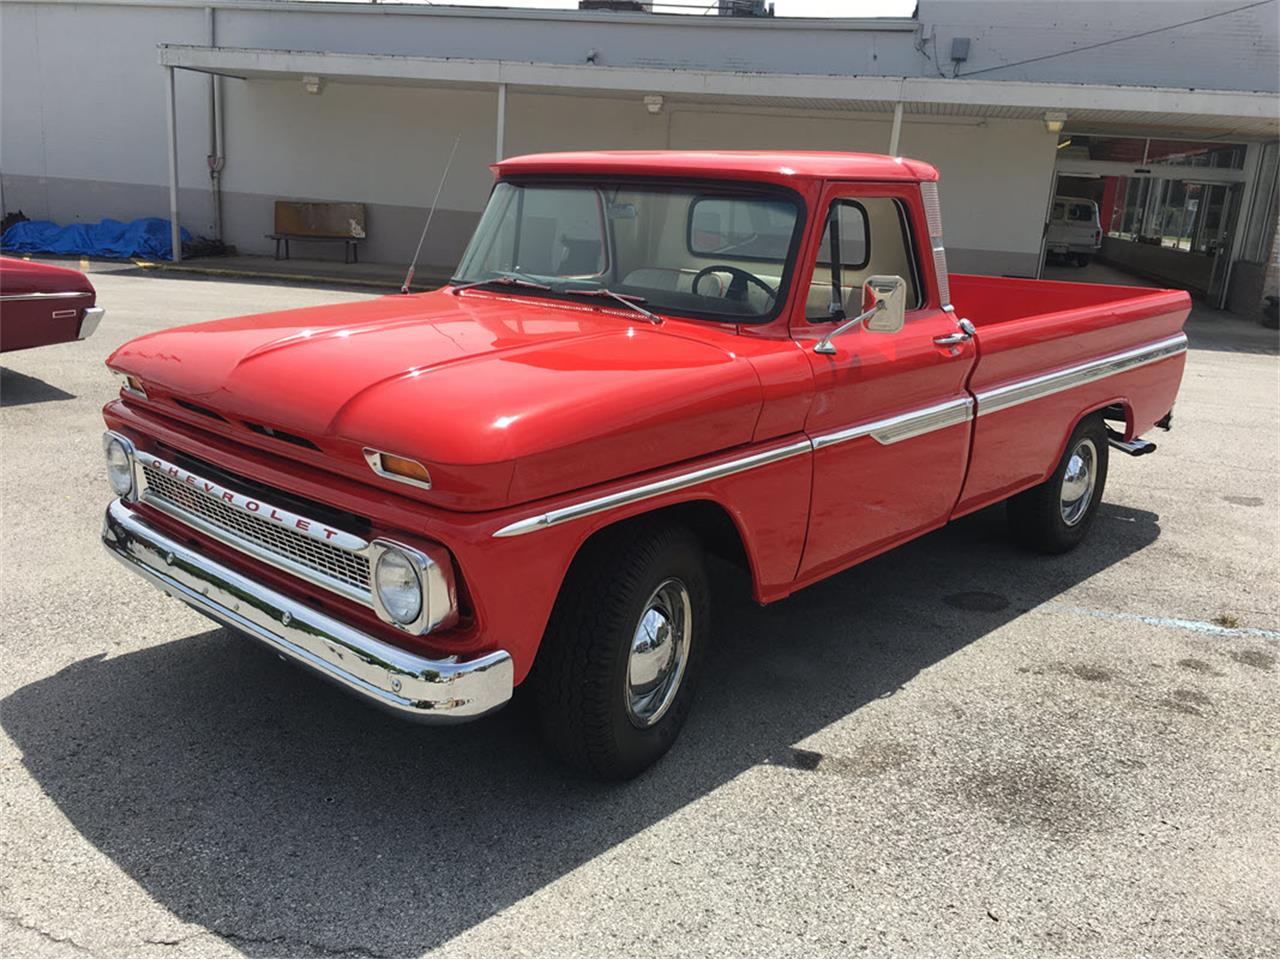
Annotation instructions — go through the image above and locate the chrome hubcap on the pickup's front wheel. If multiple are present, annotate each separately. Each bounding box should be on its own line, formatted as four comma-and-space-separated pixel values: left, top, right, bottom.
625, 580, 692, 727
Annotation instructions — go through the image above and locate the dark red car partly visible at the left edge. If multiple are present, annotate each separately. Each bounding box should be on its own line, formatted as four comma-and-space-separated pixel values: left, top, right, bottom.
0, 257, 106, 352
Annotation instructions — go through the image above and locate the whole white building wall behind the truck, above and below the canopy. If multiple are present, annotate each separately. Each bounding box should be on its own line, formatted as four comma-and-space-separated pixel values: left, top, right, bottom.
0, 0, 1277, 280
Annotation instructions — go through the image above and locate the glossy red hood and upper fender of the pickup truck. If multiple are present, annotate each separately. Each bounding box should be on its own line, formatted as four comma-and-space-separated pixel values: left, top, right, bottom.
108, 291, 762, 509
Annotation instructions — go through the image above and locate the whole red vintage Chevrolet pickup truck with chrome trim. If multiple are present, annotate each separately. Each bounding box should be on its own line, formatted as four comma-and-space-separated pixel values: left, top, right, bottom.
104, 152, 1189, 777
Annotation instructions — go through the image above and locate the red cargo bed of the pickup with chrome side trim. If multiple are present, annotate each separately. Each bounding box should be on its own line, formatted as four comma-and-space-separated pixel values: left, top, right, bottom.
951, 274, 1190, 515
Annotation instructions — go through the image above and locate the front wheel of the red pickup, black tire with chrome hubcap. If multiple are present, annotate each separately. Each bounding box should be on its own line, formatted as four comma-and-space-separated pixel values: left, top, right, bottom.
531, 522, 710, 780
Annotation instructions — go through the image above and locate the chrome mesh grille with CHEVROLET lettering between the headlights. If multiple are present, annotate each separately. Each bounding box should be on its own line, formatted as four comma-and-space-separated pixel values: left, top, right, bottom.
141, 462, 370, 594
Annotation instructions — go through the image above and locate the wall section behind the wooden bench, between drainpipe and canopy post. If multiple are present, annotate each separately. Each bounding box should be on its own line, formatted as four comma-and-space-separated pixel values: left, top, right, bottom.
215, 79, 497, 266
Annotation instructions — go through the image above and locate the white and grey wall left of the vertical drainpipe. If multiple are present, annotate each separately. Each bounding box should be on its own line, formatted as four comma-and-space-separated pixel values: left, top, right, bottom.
0, 3, 210, 233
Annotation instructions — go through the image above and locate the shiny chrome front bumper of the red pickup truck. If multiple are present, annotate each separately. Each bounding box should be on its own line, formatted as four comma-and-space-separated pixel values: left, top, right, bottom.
102, 500, 513, 723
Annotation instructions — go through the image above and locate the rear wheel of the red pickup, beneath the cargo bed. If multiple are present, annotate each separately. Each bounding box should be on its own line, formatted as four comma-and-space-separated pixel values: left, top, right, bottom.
1009, 415, 1108, 553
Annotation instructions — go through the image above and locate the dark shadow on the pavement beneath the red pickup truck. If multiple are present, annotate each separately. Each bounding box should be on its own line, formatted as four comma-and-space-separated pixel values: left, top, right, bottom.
0, 504, 1160, 956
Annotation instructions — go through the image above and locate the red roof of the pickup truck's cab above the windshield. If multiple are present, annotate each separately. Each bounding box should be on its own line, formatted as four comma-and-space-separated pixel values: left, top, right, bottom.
492, 150, 938, 184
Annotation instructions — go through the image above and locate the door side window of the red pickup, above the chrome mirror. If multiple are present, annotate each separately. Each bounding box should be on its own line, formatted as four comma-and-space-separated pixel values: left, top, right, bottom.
805, 197, 920, 321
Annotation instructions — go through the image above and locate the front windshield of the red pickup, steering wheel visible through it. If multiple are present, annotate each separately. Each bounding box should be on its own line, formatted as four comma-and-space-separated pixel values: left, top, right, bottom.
452, 180, 801, 323
